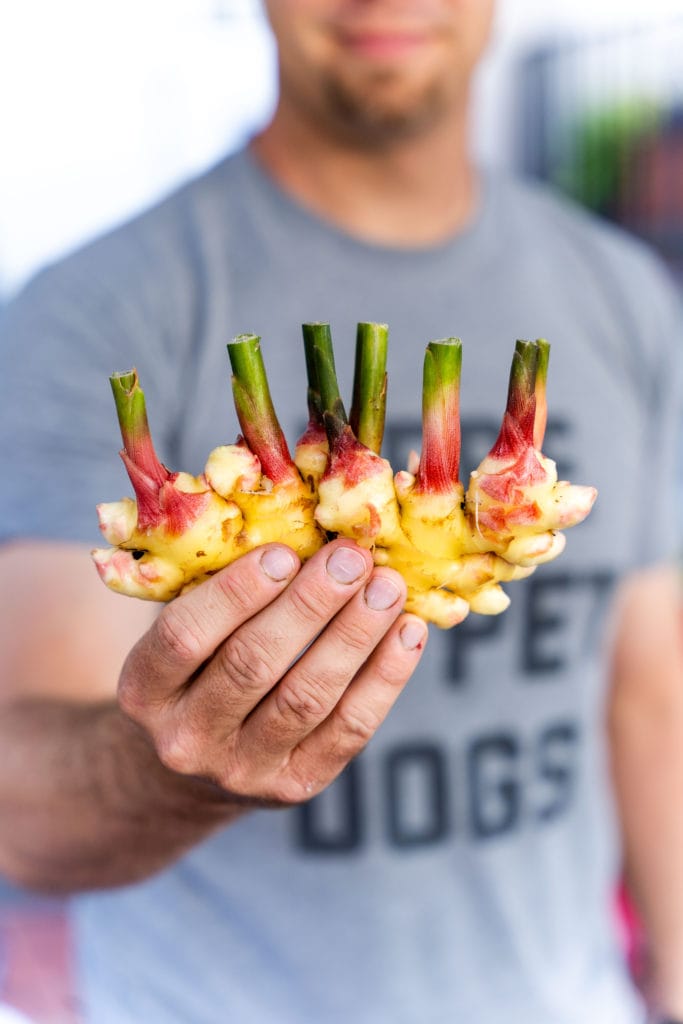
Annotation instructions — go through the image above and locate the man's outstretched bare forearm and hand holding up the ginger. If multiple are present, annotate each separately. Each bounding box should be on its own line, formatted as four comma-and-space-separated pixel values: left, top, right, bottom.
0, 541, 427, 892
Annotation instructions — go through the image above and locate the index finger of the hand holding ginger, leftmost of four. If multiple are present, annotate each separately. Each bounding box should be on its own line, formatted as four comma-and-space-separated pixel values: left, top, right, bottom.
119, 544, 300, 718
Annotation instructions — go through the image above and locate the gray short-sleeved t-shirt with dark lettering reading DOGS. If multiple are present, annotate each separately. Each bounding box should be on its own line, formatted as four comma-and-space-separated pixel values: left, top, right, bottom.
0, 146, 681, 1024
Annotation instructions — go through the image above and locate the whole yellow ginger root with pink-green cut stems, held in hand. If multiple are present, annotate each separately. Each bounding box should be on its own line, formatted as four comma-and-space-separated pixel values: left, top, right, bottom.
93, 324, 596, 628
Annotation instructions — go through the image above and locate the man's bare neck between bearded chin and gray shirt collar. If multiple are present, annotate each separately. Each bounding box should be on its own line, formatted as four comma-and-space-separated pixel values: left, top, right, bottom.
252, 97, 478, 248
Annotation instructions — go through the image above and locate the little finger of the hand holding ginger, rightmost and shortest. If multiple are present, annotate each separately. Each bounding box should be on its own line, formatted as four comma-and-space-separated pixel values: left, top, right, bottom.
289, 614, 427, 799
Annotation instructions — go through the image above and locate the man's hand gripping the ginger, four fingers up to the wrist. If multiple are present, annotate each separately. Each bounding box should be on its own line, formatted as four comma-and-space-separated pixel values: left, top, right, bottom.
119, 541, 427, 805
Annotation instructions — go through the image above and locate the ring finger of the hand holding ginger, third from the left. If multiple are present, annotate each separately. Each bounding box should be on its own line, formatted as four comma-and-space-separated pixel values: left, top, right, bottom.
240, 568, 405, 764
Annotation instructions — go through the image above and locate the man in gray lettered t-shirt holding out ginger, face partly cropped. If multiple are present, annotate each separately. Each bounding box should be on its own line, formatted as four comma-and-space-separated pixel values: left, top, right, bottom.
0, 0, 683, 1024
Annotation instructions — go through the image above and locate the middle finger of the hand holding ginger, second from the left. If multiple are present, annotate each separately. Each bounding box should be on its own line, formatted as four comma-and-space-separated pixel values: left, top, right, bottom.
177, 541, 373, 742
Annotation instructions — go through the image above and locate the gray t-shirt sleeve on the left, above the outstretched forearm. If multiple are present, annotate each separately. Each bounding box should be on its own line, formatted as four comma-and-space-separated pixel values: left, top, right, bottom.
0, 218, 194, 544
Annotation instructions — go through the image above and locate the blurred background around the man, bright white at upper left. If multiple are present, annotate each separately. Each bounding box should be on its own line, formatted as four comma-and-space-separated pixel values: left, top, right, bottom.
0, 0, 683, 1024
